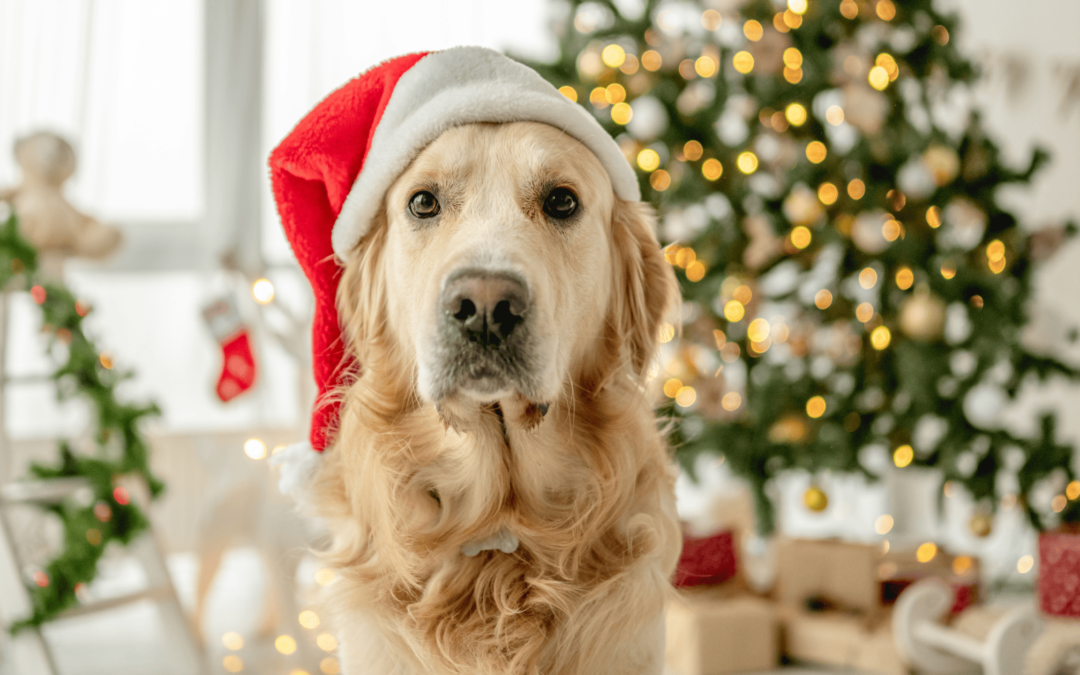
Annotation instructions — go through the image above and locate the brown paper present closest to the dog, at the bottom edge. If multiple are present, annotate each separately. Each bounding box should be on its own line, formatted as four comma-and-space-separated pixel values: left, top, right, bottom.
664, 583, 779, 675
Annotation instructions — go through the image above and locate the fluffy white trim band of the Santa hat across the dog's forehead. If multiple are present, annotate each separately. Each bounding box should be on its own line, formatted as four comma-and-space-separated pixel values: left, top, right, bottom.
333, 46, 642, 260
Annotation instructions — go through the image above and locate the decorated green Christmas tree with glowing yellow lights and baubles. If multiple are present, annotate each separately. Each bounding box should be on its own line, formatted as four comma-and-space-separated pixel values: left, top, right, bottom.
530, 0, 1080, 530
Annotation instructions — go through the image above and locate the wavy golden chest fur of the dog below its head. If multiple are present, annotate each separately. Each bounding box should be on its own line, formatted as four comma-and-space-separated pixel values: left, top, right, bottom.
323, 375, 677, 673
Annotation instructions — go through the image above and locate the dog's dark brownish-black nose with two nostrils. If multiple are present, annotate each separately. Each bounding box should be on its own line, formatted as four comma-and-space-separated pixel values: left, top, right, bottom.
443, 269, 529, 347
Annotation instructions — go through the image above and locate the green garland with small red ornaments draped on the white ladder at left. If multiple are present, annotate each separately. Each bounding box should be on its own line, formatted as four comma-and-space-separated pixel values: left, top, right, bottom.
0, 208, 163, 632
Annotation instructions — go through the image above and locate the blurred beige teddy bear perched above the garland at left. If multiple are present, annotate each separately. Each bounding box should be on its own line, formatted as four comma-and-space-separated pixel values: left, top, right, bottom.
0, 132, 121, 279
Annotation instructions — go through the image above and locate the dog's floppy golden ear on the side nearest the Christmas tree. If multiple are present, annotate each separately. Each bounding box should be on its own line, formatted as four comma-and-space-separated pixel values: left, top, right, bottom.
611, 199, 679, 377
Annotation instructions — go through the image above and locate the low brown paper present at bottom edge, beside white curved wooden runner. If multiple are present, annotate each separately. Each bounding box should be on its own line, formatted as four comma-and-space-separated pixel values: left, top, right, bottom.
781, 608, 907, 675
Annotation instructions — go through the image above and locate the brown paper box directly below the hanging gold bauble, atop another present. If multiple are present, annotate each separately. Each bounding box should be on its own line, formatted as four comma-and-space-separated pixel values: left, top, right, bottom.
777, 539, 881, 618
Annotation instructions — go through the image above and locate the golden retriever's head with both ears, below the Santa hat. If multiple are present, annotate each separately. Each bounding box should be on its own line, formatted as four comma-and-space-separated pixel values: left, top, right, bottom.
338, 122, 677, 406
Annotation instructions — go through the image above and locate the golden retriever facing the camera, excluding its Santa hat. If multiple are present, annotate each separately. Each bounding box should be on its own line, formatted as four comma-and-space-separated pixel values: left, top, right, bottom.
311, 122, 681, 675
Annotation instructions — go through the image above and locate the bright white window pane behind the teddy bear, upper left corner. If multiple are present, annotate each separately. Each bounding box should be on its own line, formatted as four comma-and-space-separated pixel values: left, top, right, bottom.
0, 0, 203, 222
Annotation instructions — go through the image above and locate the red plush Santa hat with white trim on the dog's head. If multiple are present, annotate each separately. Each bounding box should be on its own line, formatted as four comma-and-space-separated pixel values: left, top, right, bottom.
270, 46, 640, 462
